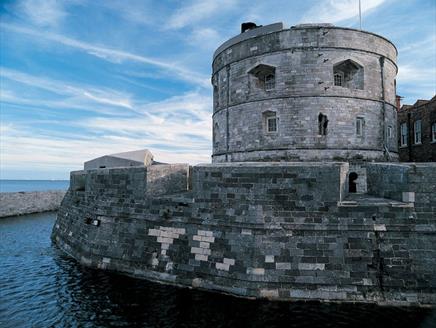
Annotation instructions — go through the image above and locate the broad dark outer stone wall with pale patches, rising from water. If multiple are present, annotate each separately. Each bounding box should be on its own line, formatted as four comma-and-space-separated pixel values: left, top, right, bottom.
52, 163, 436, 305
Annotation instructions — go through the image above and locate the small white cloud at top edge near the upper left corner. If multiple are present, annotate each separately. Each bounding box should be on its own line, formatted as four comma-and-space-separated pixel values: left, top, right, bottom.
17, 0, 67, 27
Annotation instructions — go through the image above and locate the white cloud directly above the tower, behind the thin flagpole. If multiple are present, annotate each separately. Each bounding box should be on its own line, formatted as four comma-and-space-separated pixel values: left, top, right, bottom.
301, 0, 386, 23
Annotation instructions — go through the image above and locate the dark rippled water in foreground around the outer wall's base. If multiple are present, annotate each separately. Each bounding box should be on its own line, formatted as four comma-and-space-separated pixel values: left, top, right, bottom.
0, 213, 436, 328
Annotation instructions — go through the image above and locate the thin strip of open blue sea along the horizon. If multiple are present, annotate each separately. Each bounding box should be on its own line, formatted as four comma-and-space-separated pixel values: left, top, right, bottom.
0, 179, 70, 192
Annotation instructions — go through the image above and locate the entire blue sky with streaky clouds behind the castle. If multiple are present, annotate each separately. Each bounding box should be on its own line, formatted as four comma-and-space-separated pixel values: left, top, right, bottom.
0, 0, 436, 179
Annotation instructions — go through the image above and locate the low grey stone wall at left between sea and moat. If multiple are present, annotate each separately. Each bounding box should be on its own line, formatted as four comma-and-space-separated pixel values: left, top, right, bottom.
0, 190, 65, 218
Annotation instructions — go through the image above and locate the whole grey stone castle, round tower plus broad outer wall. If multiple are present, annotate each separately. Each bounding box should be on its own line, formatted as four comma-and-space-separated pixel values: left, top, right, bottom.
52, 23, 436, 306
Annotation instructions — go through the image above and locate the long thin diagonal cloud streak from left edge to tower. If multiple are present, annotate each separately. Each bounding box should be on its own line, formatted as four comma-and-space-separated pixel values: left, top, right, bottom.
0, 23, 210, 88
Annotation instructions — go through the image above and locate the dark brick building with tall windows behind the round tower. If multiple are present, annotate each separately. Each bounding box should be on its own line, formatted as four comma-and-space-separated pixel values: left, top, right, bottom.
398, 96, 436, 162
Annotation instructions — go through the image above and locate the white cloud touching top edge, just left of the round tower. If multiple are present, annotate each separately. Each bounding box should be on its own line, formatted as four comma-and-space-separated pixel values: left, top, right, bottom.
166, 0, 238, 29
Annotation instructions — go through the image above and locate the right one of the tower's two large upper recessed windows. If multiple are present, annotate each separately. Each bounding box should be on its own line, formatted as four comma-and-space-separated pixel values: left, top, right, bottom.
333, 59, 364, 90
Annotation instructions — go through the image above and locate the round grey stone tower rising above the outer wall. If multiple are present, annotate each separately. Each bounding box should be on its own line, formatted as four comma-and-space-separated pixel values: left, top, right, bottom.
212, 23, 398, 163
